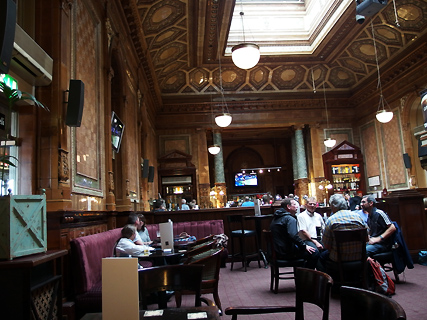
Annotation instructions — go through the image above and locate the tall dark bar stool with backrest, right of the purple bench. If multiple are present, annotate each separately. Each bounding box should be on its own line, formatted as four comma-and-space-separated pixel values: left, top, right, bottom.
227, 215, 261, 272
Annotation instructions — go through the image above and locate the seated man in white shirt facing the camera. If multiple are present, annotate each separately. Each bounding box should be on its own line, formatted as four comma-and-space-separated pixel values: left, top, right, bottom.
297, 197, 325, 251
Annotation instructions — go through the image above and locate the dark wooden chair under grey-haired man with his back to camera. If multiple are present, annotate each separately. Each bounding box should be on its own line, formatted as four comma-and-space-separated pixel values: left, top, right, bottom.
327, 228, 368, 288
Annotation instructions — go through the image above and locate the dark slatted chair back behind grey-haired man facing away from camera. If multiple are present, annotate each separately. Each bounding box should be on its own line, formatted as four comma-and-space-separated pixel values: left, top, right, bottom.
334, 228, 368, 288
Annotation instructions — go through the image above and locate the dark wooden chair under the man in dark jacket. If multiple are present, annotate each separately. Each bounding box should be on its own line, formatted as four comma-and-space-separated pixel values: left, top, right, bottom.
262, 230, 305, 294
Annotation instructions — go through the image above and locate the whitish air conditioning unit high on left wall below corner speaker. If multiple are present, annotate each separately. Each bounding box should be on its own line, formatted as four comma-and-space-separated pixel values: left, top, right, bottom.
10, 25, 53, 86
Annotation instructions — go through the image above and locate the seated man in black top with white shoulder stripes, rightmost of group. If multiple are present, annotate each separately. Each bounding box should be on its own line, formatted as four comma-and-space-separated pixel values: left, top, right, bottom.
360, 195, 396, 257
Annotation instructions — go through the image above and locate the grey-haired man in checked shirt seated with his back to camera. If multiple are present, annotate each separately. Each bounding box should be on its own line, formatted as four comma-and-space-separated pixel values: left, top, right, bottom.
317, 194, 368, 273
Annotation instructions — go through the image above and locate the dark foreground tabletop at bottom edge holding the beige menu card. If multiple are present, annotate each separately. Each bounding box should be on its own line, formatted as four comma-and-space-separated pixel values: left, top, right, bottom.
81, 306, 220, 320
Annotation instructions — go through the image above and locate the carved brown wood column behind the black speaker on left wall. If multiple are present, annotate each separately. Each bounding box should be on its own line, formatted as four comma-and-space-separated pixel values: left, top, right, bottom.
36, 0, 72, 211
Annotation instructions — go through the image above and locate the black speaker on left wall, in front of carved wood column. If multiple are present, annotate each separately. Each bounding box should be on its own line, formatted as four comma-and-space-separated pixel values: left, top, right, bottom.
65, 80, 85, 127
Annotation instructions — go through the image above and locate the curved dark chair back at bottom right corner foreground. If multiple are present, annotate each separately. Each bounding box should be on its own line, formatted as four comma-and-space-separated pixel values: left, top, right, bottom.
340, 286, 406, 320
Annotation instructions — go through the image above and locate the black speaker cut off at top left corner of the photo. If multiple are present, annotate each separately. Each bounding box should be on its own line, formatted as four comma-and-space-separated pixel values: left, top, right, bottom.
0, 0, 16, 73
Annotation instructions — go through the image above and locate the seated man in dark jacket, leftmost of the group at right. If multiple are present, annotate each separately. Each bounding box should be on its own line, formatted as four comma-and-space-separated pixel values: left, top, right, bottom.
270, 198, 319, 269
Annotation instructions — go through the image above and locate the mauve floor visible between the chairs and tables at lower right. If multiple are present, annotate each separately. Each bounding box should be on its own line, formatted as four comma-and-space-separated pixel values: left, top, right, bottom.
179, 262, 427, 320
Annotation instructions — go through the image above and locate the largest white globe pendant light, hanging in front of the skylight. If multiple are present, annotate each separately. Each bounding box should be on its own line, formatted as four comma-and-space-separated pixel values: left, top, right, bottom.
231, 1, 260, 69
